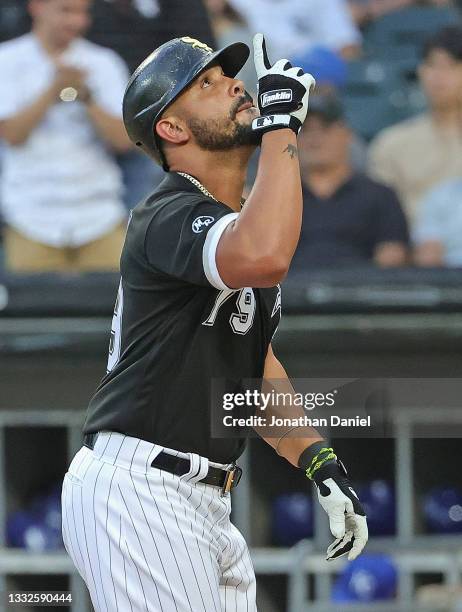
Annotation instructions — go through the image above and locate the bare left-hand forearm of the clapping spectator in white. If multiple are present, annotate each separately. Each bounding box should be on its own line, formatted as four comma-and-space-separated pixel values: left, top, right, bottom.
0, 86, 57, 146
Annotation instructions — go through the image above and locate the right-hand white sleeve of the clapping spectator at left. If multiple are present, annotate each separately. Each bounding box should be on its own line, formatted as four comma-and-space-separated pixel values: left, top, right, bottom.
89, 49, 129, 118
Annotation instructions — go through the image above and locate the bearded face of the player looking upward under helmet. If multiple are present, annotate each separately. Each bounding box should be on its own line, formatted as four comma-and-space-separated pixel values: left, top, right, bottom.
181, 66, 261, 151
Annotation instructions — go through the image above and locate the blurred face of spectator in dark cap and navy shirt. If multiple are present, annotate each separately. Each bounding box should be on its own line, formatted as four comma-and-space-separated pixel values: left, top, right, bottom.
299, 115, 351, 169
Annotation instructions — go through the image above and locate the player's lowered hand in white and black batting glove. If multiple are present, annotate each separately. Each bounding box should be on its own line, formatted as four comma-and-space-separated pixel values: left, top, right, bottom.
313, 461, 368, 561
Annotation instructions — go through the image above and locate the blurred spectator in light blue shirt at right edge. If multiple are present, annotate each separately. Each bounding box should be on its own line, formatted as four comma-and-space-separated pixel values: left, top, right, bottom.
412, 178, 462, 267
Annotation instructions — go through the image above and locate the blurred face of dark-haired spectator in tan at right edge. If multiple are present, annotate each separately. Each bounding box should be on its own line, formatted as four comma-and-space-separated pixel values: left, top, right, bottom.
419, 49, 462, 108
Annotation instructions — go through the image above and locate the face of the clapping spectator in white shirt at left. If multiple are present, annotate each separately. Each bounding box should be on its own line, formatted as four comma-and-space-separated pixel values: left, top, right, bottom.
30, 0, 92, 46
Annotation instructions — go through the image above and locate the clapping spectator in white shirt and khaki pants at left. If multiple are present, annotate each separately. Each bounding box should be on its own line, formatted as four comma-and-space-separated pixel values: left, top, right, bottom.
0, 0, 130, 272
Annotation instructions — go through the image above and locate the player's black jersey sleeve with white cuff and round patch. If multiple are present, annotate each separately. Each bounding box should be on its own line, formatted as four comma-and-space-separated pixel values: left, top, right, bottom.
145, 197, 238, 290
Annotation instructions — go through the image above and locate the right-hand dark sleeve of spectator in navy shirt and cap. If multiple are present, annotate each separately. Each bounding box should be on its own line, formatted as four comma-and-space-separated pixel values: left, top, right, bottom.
375, 185, 409, 245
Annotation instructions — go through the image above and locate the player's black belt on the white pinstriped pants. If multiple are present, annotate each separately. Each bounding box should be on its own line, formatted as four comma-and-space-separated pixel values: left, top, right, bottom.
83, 433, 242, 494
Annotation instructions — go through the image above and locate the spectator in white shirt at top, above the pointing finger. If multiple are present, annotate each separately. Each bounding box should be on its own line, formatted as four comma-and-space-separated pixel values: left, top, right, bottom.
228, 0, 361, 59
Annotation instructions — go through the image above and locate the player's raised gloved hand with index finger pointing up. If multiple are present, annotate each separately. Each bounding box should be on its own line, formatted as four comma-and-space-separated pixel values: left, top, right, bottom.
253, 34, 315, 132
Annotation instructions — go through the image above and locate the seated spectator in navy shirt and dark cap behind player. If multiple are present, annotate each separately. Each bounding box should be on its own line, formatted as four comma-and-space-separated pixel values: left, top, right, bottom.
291, 96, 408, 270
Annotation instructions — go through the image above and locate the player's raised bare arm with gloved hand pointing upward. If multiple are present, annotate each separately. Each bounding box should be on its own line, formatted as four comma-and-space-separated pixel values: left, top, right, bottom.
216, 34, 314, 288
